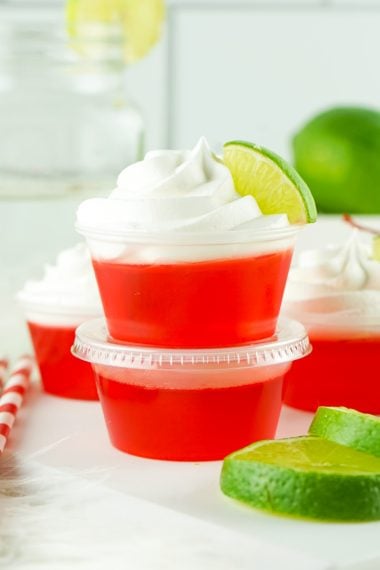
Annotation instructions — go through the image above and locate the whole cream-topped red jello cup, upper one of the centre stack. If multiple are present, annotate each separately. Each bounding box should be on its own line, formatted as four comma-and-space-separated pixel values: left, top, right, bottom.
77, 139, 314, 348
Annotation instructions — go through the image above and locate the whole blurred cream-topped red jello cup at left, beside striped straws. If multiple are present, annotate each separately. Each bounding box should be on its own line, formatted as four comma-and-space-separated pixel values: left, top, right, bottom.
18, 244, 102, 400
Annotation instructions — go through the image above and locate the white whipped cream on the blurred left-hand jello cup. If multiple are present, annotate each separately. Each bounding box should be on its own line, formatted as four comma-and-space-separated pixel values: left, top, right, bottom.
17, 243, 102, 323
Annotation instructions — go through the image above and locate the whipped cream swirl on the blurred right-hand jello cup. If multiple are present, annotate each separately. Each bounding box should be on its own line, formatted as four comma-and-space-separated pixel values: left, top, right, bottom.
284, 230, 380, 325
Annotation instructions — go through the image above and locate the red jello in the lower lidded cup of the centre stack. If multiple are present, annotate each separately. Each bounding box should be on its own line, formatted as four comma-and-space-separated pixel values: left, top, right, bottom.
95, 366, 284, 461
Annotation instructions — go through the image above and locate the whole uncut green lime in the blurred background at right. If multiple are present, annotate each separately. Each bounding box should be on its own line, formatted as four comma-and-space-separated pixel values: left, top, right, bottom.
292, 107, 380, 214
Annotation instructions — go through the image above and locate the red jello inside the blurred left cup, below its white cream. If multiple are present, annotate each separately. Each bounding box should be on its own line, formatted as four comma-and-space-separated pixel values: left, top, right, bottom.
28, 322, 98, 400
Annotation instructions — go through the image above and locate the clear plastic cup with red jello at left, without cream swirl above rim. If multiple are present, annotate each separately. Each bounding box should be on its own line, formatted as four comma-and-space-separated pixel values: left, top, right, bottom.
21, 300, 99, 400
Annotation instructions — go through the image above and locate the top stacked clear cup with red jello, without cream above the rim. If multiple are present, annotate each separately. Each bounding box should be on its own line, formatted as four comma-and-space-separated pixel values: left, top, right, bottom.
77, 225, 300, 348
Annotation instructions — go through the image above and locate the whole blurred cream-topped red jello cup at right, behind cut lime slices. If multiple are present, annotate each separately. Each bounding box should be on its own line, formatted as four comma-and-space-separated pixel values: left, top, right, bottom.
283, 230, 380, 414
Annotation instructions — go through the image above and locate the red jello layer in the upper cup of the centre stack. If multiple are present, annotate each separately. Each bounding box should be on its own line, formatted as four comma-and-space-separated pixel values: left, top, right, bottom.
93, 249, 292, 348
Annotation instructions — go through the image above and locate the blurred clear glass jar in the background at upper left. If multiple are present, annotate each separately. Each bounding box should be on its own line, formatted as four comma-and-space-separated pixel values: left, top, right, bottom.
0, 6, 143, 198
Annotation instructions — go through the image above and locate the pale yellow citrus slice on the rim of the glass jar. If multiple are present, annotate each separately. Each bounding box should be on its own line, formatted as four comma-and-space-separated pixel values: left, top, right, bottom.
66, 0, 165, 63
